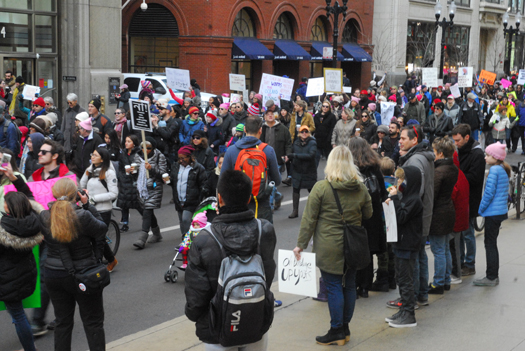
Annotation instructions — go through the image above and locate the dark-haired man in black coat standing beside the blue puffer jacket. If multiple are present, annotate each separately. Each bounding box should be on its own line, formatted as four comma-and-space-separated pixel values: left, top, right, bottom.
452, 124, 485, 276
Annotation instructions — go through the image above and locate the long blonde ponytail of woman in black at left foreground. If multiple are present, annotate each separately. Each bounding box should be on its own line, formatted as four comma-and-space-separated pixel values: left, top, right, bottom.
50, 178, 79, 243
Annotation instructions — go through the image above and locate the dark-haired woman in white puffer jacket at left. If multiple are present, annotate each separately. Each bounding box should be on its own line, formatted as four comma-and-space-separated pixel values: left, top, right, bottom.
80, 147, 118, 272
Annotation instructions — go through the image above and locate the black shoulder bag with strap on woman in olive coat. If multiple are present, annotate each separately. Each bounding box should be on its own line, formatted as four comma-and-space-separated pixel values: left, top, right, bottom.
328, 182, 370, 270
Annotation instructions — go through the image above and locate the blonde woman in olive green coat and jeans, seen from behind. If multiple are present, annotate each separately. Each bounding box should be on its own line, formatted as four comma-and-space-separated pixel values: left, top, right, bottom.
293, 145, 370, 345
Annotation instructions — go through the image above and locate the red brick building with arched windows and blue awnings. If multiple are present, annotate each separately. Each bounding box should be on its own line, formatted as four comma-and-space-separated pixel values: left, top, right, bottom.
122, 0, 374, 93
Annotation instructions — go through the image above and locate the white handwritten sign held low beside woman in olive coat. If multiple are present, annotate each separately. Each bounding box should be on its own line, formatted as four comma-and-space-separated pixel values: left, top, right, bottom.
277, 250, 317, 297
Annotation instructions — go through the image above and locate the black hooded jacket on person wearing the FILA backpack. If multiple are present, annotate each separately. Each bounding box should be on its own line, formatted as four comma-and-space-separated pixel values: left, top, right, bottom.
185, 210, 277, 344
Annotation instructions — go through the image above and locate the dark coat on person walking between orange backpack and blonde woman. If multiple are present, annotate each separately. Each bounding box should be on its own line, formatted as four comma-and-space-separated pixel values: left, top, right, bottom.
287, 137, 317, 189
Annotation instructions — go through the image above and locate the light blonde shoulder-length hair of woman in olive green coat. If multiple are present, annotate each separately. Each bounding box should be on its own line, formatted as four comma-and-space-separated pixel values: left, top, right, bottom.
324, 145, 363, 182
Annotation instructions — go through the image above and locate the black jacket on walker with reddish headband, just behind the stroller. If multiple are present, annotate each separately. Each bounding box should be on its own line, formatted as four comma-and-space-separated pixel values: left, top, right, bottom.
170, 161, 207, 213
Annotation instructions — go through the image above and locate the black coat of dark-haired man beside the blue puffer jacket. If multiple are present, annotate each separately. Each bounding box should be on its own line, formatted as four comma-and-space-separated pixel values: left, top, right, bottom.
458, 138, 485, 218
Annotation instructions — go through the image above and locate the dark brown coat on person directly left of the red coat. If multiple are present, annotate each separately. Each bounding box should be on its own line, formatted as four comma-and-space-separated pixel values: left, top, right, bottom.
429, 158, 459, 235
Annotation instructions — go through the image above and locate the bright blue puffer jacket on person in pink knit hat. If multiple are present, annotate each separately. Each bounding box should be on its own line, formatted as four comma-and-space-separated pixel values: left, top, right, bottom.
479, 165, 509, 217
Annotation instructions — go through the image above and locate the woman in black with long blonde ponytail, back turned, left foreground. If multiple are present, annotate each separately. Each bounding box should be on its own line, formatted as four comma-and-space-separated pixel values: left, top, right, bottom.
40, 178, 107, 351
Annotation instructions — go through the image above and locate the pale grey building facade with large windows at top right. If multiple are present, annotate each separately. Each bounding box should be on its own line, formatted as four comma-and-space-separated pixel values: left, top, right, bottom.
373, 0, 524, 84
